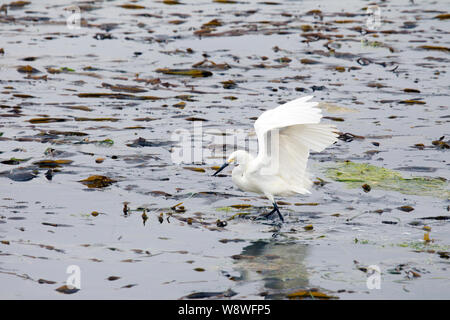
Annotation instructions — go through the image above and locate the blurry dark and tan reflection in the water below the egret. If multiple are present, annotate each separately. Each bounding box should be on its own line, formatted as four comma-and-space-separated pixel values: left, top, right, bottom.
235, 240, 308, 299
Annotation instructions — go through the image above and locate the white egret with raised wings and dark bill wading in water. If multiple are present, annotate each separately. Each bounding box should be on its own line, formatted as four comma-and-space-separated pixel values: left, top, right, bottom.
213, 96, 338, 221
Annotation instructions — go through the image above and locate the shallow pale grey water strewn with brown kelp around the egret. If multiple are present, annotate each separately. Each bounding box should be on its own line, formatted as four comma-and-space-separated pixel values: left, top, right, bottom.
0, 0, 450, 299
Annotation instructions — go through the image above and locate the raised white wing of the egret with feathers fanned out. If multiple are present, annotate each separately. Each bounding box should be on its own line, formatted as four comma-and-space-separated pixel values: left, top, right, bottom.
255, 96, 337, 193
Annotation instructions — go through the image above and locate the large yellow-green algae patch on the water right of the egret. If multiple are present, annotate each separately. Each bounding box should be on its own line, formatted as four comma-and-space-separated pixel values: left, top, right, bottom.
325, 161, 450, 199
